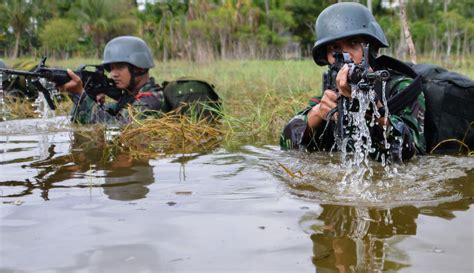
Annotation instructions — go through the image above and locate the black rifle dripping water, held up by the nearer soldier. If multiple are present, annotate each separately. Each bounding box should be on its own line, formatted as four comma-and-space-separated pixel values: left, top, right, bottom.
323, 45, 390, 138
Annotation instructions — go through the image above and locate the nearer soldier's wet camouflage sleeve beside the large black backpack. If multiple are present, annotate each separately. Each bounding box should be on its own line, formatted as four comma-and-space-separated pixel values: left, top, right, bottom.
372, 78, 426, 162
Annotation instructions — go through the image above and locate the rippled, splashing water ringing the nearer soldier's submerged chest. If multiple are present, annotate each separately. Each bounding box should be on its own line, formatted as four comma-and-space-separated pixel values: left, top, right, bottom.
270, 147, 474, 204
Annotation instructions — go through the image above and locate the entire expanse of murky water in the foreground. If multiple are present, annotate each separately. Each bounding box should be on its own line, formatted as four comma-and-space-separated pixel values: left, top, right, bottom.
0, 118, 474, 272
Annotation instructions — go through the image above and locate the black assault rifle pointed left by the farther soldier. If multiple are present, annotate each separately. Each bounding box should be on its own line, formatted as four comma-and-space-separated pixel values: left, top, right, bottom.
0, 57, 122, 110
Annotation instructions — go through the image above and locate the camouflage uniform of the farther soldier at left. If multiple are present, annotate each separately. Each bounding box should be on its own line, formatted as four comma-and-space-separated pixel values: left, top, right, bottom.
72, 78, 170, 125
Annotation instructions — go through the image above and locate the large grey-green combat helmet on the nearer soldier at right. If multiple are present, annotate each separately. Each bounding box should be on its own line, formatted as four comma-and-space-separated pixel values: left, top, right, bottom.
313, 2, 388, 66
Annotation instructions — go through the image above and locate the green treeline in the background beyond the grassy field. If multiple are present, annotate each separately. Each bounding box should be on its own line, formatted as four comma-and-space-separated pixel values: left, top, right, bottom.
0, 0, 474, 61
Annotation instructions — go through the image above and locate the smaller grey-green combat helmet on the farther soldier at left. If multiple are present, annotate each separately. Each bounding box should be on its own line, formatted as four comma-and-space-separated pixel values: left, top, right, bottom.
102, 36, 155, 69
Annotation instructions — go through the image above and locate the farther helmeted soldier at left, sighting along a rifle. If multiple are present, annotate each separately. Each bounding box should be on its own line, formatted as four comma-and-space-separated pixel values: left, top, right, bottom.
61, 36, 169, 124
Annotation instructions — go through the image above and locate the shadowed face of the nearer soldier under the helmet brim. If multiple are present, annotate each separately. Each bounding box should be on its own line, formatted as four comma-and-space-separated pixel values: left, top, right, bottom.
326, 37, 365, 64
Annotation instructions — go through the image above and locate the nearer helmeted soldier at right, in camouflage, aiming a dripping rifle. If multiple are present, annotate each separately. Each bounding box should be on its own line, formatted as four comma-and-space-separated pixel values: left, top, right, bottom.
280, 2, 425, 162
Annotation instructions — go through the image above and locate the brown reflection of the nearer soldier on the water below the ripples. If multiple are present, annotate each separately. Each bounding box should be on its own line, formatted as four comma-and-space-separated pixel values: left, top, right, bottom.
300, 187, 472, 272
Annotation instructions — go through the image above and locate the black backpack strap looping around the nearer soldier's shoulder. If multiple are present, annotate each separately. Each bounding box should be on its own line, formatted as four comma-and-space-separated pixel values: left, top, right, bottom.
375, 55, 423, 115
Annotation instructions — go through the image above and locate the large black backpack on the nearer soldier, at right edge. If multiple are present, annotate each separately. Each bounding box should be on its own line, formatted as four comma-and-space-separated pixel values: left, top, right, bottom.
412, 64, 474, 153
